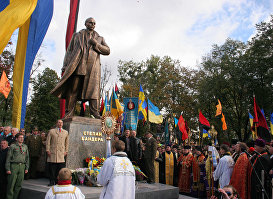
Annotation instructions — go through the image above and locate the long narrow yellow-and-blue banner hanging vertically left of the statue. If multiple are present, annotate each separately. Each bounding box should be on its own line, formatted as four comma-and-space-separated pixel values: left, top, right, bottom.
11, 0, 53, 128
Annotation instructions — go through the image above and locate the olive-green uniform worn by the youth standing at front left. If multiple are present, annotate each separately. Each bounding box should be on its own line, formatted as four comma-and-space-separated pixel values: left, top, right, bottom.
5, 143, 29, 199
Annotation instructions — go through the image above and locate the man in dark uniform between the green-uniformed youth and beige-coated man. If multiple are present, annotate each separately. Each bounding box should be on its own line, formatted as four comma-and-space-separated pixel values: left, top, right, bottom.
26, 127, 42, 179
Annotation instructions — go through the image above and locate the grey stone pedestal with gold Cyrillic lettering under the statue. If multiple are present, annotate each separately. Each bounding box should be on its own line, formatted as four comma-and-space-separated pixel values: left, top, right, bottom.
63, 116, 106, 169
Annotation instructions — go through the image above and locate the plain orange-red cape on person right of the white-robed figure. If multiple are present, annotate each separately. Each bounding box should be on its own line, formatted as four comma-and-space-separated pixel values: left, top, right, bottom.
229, 153, 249, 199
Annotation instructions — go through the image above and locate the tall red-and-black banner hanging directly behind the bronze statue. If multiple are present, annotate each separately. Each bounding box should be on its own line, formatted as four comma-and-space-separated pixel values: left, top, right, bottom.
60, 0, 79, 118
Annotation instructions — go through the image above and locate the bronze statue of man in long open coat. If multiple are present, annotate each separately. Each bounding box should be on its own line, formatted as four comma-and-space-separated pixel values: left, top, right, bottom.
51, 18, 110, 118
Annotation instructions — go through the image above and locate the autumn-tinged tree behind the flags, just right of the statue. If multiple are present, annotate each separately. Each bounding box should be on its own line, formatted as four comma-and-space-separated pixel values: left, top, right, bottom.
118, 55, 201, 132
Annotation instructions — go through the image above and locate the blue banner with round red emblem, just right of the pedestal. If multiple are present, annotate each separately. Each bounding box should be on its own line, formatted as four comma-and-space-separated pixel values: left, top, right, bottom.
123, 97, 138, 130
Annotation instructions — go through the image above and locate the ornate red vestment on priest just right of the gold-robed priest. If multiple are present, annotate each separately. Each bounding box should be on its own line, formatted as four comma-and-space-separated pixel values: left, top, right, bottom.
177, 153, 193, 193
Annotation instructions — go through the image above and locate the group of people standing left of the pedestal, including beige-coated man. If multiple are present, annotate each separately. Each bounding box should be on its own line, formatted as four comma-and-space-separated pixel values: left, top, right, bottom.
0, 120, 68, 199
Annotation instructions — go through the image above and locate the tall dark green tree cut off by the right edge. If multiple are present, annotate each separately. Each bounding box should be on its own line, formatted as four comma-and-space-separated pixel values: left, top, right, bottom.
245, 15, 273, 112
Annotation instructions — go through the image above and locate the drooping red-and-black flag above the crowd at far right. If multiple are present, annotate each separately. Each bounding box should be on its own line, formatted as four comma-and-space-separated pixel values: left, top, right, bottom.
253, 97, 271, 142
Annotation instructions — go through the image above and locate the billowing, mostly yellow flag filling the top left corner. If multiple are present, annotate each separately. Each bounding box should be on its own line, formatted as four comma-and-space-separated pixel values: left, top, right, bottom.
0, 0, 37, 54
